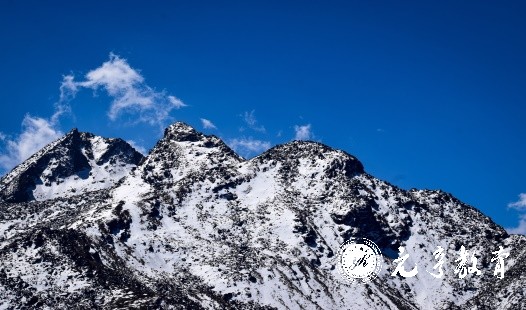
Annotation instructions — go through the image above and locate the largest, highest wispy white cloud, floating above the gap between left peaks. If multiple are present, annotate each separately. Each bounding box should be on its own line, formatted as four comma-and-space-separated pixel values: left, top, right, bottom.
60, 54, 186, 126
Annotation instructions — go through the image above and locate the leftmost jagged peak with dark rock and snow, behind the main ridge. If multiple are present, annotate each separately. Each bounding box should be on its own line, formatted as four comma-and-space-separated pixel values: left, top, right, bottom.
0, 128, 143, 202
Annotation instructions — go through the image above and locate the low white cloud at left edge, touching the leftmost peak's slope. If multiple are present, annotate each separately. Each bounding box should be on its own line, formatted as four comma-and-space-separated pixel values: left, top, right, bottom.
0, 115, 63, 171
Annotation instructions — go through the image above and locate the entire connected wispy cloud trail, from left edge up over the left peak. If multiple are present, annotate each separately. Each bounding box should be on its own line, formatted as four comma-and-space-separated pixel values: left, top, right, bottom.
0, 54, 186, 171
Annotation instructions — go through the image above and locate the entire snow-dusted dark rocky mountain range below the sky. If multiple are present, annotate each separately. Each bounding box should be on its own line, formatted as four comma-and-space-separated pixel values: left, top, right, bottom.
0, 123, 526, 309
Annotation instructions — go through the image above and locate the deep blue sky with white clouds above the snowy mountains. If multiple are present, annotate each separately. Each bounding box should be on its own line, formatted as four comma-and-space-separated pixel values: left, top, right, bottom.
0, 1, 526, 232
